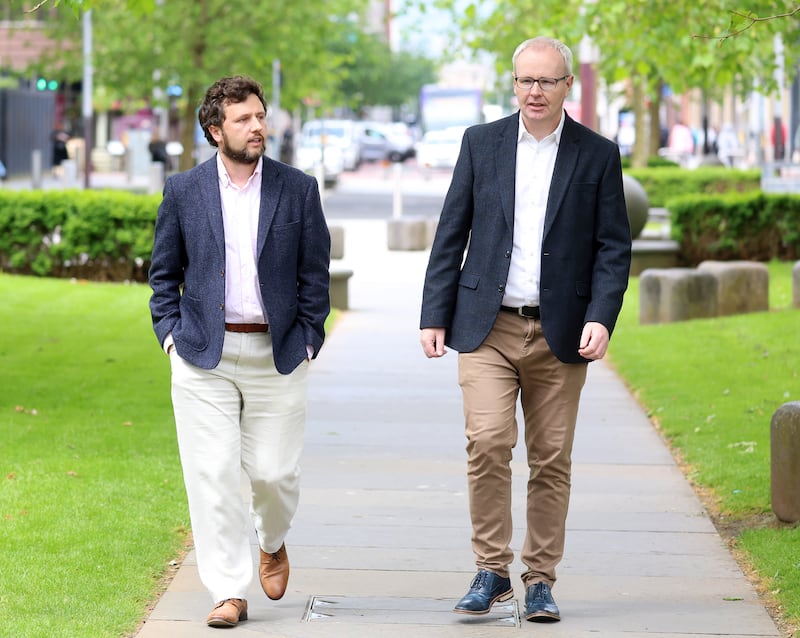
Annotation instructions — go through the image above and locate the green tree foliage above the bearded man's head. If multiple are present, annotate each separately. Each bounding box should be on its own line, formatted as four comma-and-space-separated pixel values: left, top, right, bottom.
32, 0, 432, 168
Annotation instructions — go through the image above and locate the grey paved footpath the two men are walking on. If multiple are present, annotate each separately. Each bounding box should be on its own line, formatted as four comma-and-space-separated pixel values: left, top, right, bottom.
133, 221, 780, 638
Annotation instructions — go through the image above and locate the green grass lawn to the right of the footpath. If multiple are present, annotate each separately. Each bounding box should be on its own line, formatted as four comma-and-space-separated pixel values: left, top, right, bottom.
609, 263, 800, 626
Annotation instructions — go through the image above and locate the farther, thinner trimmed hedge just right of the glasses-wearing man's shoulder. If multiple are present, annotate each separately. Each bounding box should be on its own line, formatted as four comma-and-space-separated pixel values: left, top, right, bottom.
625, 166, 761, 208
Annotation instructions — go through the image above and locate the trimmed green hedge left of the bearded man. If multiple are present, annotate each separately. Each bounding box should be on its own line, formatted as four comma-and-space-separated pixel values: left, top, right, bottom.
0, 190, 161, 281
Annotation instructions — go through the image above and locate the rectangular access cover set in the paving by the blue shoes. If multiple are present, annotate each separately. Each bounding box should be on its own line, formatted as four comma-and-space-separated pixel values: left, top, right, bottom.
303, 595, 520, 628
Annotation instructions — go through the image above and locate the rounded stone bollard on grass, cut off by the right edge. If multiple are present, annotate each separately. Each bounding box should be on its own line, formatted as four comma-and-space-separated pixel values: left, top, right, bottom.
769, 401, 800, 523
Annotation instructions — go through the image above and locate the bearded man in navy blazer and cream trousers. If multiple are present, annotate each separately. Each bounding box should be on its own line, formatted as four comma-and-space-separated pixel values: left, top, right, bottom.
150, 76, 330, 627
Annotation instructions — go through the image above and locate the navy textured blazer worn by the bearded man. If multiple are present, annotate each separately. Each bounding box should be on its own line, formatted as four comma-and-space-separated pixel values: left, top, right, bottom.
150, 156, 330, 374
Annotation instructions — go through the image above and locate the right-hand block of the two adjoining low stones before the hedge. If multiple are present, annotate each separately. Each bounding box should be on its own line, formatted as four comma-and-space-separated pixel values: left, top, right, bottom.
697, 260, 769, 317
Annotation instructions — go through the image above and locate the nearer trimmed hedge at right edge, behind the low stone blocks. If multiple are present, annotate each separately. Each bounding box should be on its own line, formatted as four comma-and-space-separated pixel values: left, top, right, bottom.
667, 191, 800, 266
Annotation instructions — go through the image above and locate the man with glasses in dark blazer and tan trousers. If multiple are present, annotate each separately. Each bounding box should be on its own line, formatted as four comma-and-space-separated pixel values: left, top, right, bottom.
420, 37, 631, 622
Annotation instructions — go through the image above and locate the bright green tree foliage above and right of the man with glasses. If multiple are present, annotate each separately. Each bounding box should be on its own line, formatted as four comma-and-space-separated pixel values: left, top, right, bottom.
422, 0, 800, 164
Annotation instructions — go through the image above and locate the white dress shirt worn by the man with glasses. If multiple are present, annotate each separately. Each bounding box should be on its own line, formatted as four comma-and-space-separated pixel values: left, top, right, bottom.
503, 112, 564, 308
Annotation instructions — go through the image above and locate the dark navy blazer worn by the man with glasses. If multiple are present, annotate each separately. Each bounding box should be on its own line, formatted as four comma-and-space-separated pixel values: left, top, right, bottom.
420, 113, 631, 363
